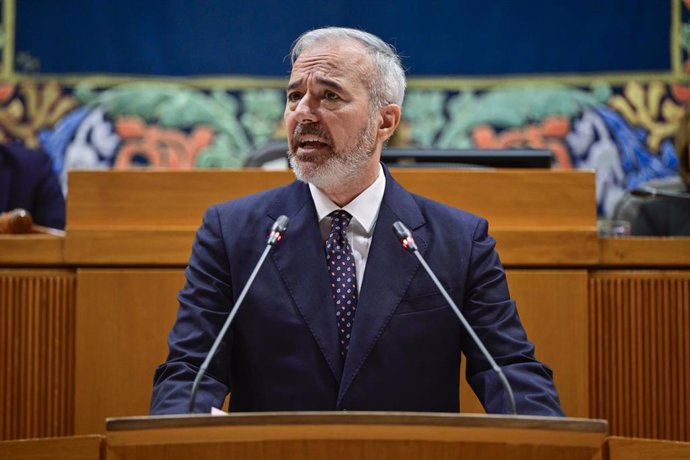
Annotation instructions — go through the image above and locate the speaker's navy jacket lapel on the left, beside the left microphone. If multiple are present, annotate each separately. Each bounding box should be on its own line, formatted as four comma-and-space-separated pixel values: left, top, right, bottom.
269, 182, 342, 382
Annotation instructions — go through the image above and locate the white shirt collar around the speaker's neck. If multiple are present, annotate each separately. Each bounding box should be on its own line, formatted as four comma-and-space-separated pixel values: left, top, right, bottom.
309, 164, 386, 234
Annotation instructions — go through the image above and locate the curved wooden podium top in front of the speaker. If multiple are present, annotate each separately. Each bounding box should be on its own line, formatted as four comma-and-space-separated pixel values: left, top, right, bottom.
105, 412, 608, 460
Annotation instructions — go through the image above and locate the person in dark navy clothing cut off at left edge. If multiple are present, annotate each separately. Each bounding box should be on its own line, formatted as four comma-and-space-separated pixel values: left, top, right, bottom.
0, 144, 65, 229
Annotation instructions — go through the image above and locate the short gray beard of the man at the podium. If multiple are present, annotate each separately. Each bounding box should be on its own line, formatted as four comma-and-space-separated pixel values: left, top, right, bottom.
288, 117, 376, 190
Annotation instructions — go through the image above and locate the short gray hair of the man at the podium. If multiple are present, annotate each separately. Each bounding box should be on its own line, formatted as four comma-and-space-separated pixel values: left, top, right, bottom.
290, 27, 407, 109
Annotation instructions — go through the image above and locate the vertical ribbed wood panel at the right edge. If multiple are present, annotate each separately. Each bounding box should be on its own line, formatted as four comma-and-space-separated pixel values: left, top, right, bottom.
589, 271, 690, 441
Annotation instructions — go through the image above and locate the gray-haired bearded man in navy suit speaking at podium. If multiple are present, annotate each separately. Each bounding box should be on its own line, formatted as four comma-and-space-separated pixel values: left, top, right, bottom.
151, 28, 562, 415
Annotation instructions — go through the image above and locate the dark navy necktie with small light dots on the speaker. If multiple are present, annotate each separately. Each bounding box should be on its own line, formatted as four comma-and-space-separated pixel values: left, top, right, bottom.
326, 209, 357, 358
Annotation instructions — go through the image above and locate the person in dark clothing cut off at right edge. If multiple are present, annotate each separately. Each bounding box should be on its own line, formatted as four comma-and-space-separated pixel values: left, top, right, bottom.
630, 106, 690, 236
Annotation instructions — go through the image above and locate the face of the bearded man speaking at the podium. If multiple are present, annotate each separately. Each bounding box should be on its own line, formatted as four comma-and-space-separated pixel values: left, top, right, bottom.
284, 40, 380, 189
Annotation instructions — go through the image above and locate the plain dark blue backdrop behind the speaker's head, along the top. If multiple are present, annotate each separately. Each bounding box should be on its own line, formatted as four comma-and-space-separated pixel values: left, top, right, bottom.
16, 0, 672, 76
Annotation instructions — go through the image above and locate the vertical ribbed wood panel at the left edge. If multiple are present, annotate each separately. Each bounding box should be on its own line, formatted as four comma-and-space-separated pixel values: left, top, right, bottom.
0, 270, 76, 440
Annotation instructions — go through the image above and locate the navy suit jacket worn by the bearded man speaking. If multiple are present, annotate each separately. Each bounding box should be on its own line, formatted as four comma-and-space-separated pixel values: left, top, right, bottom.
151, 166, 562, 415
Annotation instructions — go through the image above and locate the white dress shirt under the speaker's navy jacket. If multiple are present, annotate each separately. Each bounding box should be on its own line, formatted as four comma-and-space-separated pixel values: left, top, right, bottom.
309, 165, 386, 292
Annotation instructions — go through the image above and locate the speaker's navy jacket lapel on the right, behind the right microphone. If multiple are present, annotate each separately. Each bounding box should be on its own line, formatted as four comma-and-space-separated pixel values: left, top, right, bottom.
338, 170, 427, 404
